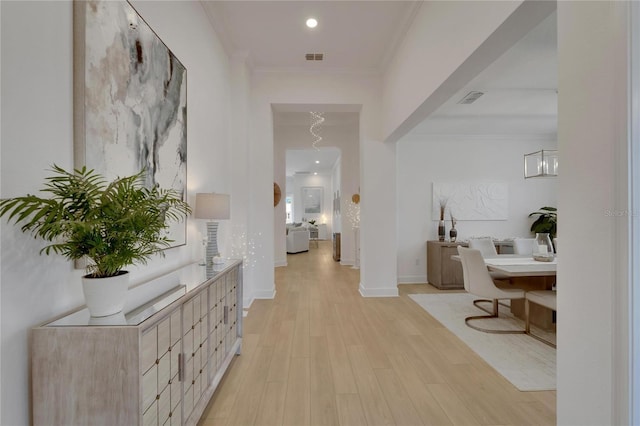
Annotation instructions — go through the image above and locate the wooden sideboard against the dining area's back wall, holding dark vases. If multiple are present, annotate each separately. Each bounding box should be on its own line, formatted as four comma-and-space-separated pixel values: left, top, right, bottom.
427, 241, 466, 290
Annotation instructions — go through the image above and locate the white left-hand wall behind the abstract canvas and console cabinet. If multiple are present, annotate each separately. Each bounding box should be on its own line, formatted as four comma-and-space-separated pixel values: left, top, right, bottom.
0, 1, 234, 425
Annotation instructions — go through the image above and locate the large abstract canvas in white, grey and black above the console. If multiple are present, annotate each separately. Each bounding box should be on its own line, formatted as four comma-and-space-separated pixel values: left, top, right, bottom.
74, 1, 187, 246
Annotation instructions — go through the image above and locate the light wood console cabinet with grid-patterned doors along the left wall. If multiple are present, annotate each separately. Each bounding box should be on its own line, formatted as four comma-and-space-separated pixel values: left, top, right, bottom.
31, 261, 242, 426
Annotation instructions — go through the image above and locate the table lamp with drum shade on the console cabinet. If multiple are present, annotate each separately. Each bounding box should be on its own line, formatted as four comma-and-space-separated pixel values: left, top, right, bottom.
195, 193, 231, 265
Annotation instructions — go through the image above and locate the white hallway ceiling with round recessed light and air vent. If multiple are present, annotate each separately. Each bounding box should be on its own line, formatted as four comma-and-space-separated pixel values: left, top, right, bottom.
203, 0, 421, 73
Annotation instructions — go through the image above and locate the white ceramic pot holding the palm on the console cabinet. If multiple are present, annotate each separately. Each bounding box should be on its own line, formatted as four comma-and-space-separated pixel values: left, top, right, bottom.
82, 271, 129, 317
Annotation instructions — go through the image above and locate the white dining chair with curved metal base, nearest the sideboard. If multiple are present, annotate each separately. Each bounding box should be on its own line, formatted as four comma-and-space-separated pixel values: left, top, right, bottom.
458, 246, 525, 334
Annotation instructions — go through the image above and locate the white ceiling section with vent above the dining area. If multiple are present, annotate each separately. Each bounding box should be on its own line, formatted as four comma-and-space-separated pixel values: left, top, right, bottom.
410, 13, 558, 137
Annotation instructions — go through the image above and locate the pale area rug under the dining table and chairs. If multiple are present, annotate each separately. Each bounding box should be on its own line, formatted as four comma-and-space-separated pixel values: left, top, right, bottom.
409, 293, 556, 391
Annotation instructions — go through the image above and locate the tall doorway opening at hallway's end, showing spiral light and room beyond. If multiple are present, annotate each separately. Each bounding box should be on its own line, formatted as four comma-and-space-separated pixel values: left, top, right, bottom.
272, 104, 360, 267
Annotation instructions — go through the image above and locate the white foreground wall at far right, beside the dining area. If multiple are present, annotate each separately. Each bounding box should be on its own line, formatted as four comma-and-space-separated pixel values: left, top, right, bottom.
557, 1, 638, 425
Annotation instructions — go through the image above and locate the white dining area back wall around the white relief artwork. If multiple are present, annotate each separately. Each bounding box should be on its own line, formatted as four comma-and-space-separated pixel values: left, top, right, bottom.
397, 135, 557, 283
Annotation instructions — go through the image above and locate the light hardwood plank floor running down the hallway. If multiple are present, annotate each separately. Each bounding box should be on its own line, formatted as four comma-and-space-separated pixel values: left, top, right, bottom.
200, 241, 556, 426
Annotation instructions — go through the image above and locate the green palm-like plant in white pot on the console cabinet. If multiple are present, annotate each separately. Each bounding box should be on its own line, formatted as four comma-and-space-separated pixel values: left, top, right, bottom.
0, 165, 191, 317
